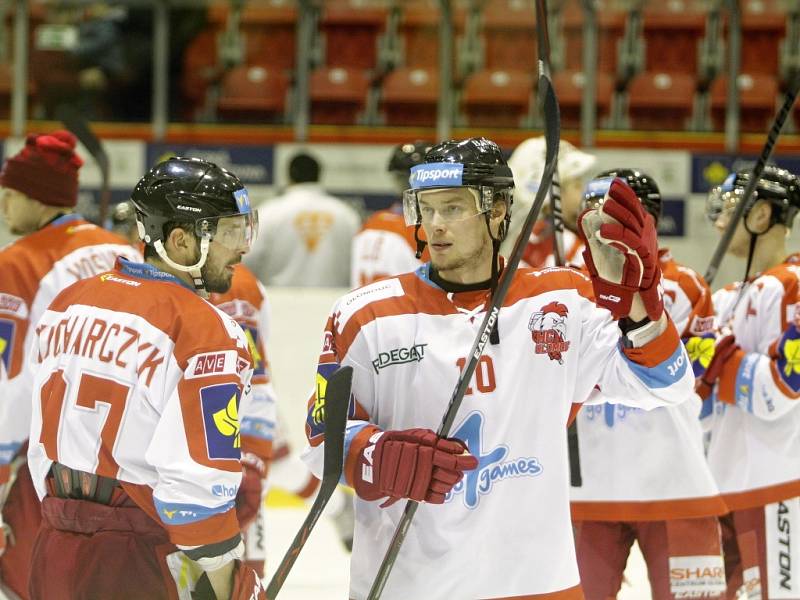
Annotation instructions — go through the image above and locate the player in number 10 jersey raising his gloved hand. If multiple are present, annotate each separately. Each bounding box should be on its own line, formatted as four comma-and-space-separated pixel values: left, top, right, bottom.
305, 138, 694, 600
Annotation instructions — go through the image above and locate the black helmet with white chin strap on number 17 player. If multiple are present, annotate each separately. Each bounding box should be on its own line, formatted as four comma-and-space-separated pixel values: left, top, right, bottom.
131, 157, 258, 291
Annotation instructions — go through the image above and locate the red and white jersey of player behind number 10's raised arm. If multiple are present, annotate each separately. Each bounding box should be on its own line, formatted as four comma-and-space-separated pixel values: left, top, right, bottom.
571, 250, 727, 521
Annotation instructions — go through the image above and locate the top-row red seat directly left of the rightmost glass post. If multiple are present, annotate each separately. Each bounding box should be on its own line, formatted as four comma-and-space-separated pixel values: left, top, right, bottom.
644, 0, 706, 74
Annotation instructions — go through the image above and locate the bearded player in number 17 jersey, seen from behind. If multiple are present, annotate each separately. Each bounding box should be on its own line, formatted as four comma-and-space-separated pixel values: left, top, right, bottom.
28, 158, 265, 599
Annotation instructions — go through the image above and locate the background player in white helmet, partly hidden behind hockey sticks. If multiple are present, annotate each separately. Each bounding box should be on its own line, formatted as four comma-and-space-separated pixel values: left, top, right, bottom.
501, 137, 597, 267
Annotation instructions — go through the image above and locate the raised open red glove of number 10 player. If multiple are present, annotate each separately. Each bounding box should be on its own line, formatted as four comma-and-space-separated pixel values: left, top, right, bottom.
578, 178, 664, 321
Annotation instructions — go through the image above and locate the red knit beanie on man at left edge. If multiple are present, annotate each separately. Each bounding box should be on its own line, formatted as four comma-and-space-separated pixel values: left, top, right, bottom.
0, 131, 83, 206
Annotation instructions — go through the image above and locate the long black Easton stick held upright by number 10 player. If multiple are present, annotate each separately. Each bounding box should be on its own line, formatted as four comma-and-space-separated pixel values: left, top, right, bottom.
367, 23, 560, 600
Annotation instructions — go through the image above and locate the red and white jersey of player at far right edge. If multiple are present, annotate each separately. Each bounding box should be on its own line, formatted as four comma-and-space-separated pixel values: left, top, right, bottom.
707, 255, 800, 510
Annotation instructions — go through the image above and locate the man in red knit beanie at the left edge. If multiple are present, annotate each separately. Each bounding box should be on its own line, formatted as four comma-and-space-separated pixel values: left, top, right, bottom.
0, 131, 140, 598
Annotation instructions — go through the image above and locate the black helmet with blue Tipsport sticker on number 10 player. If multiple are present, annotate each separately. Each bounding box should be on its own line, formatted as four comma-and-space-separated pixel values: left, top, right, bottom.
403, 137, 514, 234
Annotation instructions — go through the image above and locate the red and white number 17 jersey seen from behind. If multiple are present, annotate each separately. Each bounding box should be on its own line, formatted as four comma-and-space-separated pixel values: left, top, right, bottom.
28, 260, 252, 548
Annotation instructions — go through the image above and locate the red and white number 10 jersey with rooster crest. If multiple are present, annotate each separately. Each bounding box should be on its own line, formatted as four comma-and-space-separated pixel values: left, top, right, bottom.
304, 265, 694, 600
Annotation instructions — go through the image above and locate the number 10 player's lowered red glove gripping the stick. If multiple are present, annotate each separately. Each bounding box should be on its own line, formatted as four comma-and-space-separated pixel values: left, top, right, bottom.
354, 429, 478, 507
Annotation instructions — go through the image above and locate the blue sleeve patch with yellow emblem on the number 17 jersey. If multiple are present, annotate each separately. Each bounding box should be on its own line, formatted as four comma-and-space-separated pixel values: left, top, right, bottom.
200, 383, 241, 460
